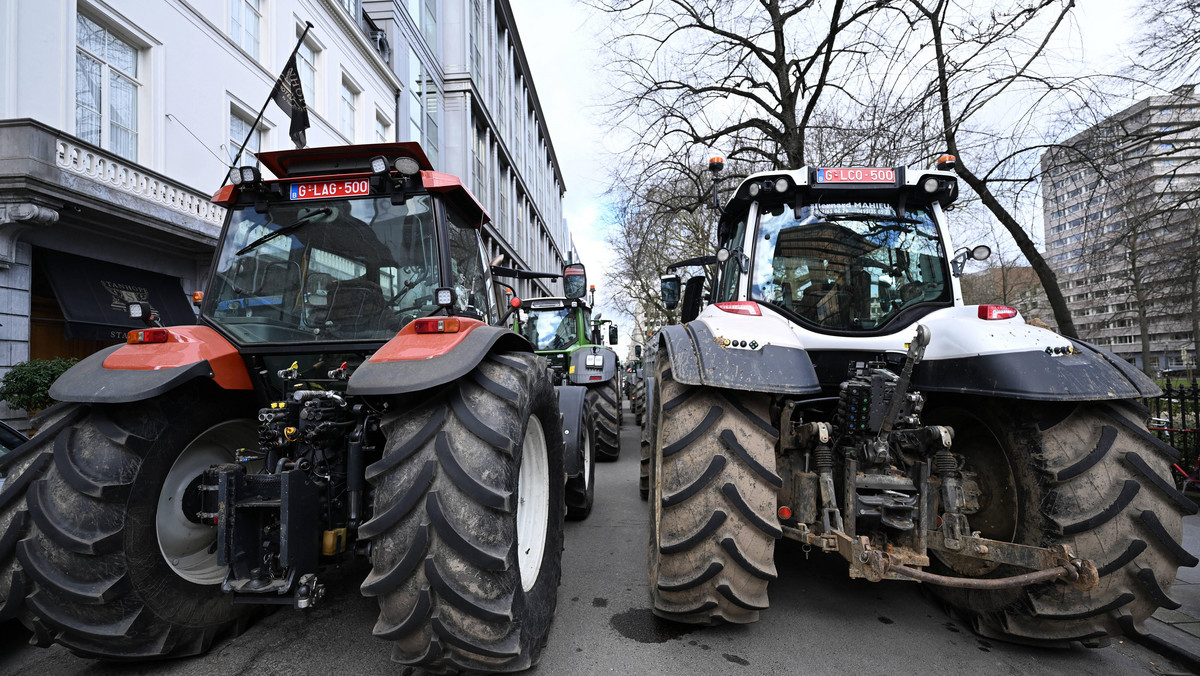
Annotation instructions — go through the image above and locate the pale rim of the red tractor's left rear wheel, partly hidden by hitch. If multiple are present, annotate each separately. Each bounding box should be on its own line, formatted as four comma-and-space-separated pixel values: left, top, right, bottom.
155, 420, 256, 585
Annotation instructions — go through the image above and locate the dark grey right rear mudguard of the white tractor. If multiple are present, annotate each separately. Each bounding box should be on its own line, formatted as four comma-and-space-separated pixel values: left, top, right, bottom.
912, 339, 1163, 401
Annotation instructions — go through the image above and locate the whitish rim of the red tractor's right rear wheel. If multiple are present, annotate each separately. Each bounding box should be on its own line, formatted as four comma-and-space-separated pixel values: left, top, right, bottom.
517, 415, 550, 592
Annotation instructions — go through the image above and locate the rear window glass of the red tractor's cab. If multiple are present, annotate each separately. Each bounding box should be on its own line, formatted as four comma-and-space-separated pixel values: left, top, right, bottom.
203, 196, 438, 343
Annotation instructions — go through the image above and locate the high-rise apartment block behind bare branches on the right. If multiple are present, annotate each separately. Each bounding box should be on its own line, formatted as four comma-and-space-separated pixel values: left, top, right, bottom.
1042, 85, 1200, 372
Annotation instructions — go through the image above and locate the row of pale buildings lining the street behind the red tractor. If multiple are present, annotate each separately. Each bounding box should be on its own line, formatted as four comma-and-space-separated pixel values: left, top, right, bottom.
0, 0, 571, 417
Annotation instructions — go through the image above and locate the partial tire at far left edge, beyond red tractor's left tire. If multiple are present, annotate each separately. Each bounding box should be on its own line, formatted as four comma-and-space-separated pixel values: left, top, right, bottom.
0, 403, 86, 622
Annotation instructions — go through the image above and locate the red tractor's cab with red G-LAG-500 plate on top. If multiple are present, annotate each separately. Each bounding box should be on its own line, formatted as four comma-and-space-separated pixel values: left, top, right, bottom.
200, 143, 497, 347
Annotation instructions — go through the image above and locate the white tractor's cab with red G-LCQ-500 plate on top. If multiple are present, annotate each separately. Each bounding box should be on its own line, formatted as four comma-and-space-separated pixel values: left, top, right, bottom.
714, 162, 959, 334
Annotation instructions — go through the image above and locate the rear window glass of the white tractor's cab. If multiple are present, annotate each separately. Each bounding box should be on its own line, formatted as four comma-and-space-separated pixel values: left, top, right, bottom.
750, 203, 952, 330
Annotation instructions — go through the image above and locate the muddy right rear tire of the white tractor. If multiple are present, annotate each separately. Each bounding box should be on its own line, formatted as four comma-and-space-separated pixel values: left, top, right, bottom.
924, 399, 1196, 646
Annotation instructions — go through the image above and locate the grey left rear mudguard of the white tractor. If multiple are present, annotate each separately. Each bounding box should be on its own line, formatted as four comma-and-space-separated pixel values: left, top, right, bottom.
660, 322, 821, 394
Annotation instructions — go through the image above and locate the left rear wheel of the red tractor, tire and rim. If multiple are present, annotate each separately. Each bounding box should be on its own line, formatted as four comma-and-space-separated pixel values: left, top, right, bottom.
17, 382, 257, 660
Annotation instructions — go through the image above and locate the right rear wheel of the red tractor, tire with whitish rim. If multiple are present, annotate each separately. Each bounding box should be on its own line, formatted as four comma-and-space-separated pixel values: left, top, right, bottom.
359, 353, 565, 672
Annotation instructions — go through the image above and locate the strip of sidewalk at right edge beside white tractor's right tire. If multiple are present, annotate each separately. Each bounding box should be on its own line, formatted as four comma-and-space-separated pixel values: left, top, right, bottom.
1130, 511, 1200, 672
